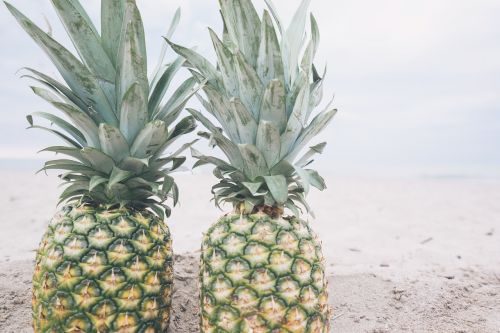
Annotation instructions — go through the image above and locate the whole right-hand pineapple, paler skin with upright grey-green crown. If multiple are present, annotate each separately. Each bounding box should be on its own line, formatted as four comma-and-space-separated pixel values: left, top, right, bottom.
170, 0, 336, 333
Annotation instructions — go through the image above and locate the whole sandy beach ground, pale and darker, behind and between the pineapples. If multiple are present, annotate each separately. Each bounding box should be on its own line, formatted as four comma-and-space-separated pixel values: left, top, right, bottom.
0, 171, 500, 333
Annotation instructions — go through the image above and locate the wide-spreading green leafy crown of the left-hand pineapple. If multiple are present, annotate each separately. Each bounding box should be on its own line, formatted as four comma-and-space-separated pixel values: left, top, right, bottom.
6, 0, 201, 216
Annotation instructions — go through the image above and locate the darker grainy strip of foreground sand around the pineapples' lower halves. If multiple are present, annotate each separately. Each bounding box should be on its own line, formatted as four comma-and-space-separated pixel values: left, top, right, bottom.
0, 255, 500, 333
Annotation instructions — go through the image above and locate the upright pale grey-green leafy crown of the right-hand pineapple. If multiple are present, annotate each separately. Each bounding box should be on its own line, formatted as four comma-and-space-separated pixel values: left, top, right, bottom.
170, 0, 336, 216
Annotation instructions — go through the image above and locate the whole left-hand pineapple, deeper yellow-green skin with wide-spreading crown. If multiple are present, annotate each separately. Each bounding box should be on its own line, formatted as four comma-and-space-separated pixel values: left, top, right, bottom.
6, 0, 198, 333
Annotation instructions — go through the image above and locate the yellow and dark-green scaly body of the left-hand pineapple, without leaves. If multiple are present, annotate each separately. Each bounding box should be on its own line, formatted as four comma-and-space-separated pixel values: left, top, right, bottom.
32, 205, 173, 333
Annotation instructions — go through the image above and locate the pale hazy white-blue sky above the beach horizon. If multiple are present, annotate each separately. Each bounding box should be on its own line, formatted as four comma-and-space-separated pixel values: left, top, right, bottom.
0, 0, 500, 177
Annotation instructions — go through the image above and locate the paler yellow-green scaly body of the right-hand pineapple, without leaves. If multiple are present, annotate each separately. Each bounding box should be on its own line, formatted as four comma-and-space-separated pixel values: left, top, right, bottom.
200, 212, 331, 333
